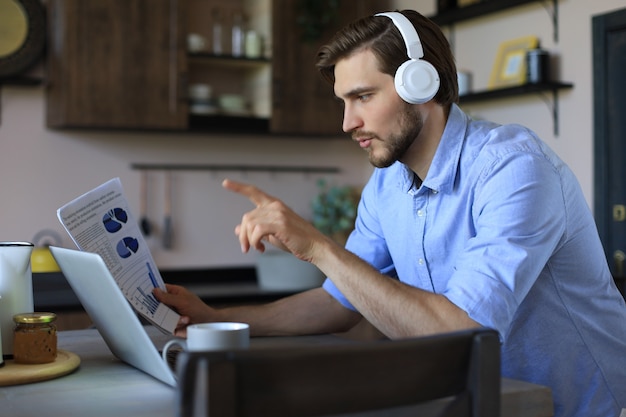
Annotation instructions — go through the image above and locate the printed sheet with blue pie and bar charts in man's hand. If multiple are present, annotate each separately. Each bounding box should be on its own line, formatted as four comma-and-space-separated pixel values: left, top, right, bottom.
57, 178, 179, 334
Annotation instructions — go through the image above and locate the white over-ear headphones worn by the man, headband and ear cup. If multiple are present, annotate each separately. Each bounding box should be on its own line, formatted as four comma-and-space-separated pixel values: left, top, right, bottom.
376, 12, 440, 104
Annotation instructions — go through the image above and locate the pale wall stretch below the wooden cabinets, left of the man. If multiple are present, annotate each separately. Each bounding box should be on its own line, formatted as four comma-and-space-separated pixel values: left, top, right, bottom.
0, 87, 371, 267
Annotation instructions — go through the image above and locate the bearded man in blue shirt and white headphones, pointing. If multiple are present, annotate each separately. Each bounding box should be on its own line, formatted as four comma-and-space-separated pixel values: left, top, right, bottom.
156, 11, 626, 417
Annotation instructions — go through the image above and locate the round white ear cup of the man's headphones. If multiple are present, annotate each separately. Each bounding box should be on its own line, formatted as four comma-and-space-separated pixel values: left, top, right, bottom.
394, 59, 440, 104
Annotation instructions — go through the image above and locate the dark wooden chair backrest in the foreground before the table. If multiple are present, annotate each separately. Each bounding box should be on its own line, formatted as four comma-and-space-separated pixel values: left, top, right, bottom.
177, 328, 500, 417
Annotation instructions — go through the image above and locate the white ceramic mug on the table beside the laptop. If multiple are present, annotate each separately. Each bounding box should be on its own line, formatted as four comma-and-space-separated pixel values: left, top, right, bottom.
161, 322, 250, 361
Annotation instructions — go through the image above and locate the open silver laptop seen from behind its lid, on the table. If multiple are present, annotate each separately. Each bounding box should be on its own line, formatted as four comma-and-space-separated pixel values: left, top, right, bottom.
50, 246, 176, 386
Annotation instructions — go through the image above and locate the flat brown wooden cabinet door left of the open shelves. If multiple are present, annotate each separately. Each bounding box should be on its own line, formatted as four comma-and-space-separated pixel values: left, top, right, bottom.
46, 0, 188, 129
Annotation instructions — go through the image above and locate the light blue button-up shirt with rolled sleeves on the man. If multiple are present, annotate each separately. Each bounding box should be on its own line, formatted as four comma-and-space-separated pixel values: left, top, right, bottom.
324, 105, 626, 417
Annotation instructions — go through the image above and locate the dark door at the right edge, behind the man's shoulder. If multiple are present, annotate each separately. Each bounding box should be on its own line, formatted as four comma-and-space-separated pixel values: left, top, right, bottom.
592, 9, 626, 295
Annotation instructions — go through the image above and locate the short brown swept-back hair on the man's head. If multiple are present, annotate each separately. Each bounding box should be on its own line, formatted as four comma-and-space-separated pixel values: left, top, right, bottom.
316, 10, 459, 107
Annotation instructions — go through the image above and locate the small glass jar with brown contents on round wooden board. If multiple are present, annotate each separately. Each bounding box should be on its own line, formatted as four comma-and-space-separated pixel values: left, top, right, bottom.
13, 313, 57, 364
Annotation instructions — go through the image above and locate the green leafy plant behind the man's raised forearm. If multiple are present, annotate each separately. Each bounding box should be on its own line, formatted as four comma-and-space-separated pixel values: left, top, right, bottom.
311, 179, 361, 245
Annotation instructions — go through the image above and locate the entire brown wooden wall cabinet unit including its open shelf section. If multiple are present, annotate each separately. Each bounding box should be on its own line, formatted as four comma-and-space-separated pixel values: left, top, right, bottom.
46, 0, 388, 135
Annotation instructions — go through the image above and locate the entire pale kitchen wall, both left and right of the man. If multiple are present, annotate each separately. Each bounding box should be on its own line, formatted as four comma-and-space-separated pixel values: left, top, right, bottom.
0, 0, 625, 268
